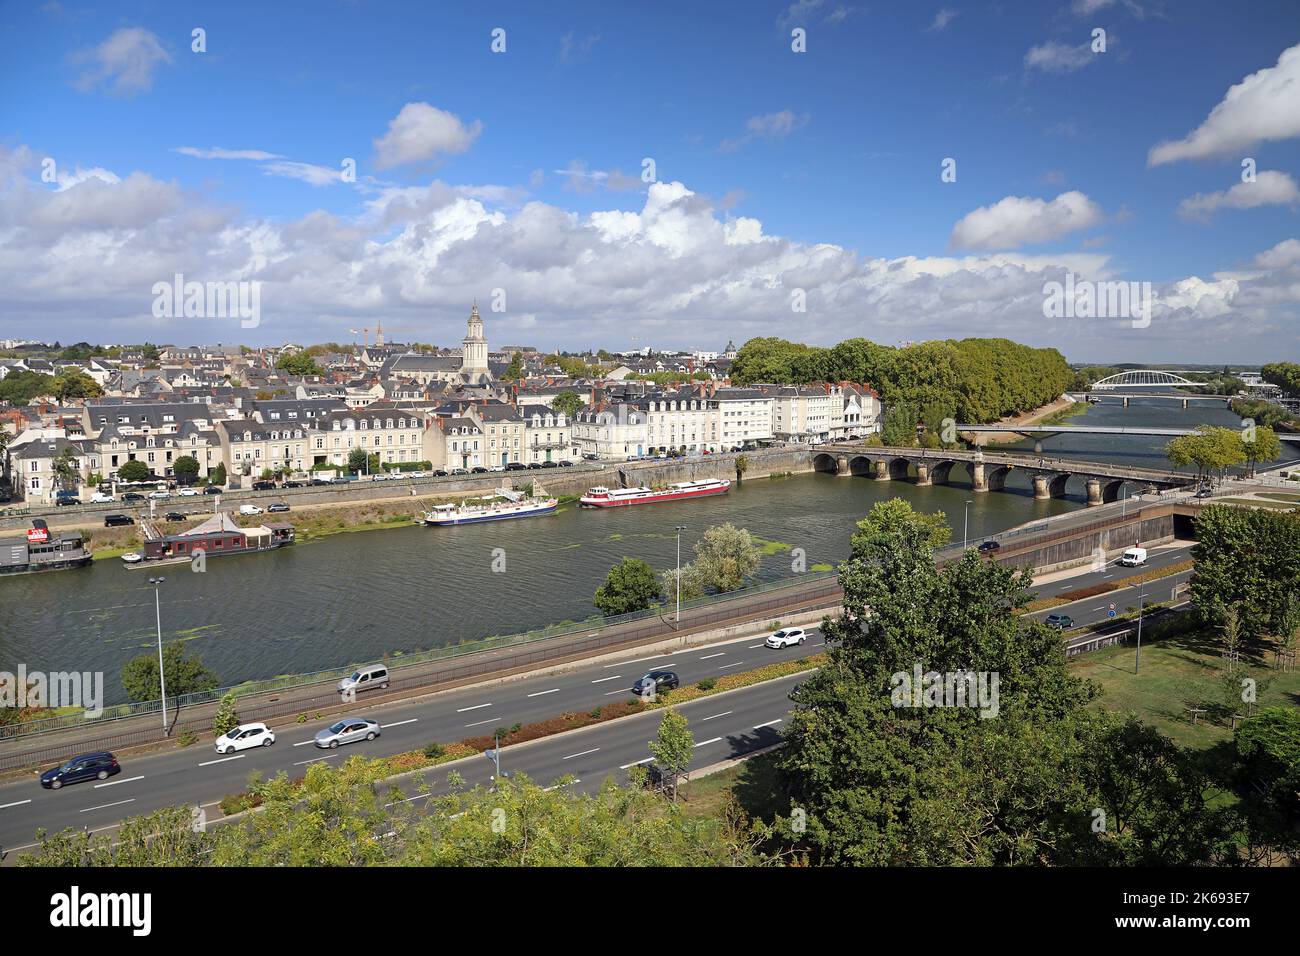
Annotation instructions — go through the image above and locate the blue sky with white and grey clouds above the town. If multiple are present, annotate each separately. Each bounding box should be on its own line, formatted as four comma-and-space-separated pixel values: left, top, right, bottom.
0, 0, 1300, 362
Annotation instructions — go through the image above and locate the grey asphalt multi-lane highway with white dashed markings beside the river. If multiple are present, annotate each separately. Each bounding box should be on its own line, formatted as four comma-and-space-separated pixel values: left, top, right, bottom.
0, 542, 1190, 864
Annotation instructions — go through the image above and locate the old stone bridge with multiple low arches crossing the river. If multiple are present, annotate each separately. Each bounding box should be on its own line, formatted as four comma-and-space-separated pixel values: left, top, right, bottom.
813, 444, 1196, 507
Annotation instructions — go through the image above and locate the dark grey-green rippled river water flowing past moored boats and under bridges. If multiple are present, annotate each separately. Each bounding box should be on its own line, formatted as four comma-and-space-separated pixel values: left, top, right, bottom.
0, 402, 1279, 704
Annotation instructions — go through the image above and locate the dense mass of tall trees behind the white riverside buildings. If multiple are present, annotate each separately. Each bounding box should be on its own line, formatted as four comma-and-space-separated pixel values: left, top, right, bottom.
732, 338, 1075, 425
